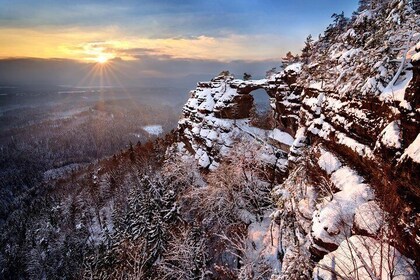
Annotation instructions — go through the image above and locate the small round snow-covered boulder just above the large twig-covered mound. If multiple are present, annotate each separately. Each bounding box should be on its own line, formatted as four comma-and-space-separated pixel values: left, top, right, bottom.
354, 200, 386, 235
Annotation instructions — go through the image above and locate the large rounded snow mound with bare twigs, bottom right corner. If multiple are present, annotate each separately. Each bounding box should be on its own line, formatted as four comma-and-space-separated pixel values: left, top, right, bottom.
313, 235, 418, 280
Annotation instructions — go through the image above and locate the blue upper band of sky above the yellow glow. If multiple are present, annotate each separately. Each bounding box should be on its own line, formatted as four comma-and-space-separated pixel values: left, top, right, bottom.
0, 0, 357, 37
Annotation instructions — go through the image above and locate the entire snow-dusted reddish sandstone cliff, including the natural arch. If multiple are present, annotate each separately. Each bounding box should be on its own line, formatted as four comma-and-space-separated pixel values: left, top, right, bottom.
179, 1, 420, 272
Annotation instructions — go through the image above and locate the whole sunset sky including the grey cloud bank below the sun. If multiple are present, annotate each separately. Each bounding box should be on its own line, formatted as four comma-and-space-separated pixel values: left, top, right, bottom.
0, 0, 358, 86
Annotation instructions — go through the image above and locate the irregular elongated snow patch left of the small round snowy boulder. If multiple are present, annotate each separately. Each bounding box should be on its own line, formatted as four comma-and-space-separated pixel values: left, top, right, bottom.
312, 166, 373, 245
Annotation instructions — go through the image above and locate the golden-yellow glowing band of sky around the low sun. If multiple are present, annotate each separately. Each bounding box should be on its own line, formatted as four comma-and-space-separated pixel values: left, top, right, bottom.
0, 27, 282, 62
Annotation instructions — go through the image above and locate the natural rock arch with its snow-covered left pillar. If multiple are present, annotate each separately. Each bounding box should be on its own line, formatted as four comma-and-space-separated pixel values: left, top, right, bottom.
179, 64, 301, 169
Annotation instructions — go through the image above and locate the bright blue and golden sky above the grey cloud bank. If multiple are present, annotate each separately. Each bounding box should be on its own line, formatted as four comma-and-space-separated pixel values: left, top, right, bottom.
0, 0, 357, 62
